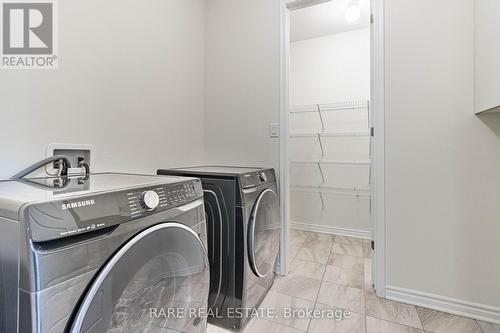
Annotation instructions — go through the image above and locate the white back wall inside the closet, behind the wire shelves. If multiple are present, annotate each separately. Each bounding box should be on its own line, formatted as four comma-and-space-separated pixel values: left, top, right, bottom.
289, 28, 371, 238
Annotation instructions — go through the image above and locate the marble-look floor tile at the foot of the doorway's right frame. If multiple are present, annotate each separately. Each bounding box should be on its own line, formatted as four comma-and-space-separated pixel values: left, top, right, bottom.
365, 289, 422, 329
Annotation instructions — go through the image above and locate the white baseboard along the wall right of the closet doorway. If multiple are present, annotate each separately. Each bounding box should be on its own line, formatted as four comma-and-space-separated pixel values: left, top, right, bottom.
385, 286, 500, 324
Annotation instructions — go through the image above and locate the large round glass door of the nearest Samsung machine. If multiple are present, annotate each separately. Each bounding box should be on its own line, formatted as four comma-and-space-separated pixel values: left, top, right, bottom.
70, 222, 210, 333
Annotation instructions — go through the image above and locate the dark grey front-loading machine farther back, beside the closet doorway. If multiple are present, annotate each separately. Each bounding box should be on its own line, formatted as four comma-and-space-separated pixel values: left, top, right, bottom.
158, 166, 281, 331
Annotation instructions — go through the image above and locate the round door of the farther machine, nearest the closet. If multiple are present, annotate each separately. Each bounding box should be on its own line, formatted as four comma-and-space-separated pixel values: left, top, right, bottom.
248, 189, 280, 277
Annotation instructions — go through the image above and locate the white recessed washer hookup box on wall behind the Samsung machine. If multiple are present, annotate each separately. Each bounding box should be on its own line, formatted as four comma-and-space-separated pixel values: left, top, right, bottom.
45, 143, 94, 175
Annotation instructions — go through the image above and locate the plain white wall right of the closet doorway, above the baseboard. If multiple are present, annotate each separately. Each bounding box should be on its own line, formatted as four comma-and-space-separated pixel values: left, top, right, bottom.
385, 0, 500, 307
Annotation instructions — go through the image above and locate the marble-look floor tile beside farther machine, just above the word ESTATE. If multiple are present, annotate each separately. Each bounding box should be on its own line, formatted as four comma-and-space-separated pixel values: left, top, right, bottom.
271, 274, 321, 302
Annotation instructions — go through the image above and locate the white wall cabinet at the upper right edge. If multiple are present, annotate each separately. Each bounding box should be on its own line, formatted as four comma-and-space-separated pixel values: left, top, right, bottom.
474, 0, 500, 113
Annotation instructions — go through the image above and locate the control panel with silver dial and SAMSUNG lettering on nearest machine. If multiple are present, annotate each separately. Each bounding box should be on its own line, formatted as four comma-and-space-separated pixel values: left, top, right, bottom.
24, 179, 203, 242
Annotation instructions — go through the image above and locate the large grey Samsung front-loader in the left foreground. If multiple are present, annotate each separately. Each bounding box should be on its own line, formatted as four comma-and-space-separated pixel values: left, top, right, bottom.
0, 173, 210, 333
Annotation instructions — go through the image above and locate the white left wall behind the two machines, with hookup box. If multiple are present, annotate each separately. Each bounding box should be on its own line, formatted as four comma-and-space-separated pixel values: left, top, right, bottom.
0, 0, 205, 178
